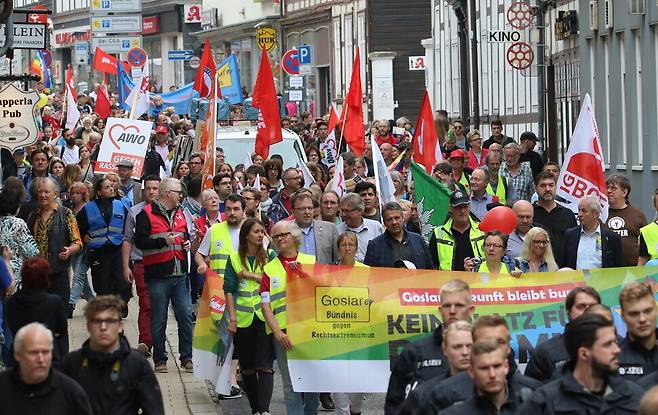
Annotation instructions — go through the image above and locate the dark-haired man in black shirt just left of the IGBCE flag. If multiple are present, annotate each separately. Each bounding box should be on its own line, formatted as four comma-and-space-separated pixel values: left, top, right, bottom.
533, 171, 576, 267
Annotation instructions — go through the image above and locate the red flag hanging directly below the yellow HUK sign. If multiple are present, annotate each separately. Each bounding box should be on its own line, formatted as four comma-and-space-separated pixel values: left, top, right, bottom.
252, 48, 283, 159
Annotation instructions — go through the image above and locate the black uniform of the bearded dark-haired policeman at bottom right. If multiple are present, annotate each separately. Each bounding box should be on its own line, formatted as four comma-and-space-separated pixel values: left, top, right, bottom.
518, 370, 644, 415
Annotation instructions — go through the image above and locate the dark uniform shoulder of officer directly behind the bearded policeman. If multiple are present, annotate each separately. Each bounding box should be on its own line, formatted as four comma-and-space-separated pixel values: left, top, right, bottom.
524, 334, 570, 383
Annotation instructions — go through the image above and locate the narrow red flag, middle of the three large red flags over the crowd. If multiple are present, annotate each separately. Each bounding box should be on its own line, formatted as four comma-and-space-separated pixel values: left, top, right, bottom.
341, 48, 366, 156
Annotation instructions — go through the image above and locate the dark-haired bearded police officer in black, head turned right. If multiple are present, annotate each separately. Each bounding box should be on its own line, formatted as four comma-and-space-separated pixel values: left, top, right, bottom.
518, 313, 644, 415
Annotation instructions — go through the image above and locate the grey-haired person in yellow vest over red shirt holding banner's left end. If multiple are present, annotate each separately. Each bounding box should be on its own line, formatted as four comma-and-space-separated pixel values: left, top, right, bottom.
260, 221, 320, 415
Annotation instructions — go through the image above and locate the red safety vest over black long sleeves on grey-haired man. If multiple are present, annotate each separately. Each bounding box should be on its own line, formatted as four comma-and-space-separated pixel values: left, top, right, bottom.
142, 203, 189, 265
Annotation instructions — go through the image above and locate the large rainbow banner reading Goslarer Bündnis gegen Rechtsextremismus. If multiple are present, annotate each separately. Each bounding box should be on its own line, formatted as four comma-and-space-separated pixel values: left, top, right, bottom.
286, 265, 658, 392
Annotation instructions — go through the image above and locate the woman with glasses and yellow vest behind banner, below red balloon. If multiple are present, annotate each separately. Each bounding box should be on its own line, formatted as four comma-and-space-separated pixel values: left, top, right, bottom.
464, 231, 522, 277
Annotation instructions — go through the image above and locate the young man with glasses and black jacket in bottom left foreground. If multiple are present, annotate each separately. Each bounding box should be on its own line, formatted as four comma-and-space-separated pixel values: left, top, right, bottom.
61, 295, 164, 414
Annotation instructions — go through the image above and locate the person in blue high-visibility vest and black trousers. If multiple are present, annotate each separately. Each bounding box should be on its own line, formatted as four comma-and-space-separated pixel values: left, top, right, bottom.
76, 177, 132, 313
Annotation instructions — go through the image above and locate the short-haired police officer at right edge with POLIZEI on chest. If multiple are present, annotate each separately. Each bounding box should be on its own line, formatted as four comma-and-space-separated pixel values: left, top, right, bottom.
619, 282, 658, 381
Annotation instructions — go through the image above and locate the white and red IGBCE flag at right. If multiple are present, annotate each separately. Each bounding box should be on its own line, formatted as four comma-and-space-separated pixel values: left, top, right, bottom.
556, 94, 608, 222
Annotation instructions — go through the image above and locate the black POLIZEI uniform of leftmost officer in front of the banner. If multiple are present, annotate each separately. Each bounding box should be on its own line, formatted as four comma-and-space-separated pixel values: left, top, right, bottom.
384, 326, 450, 415
